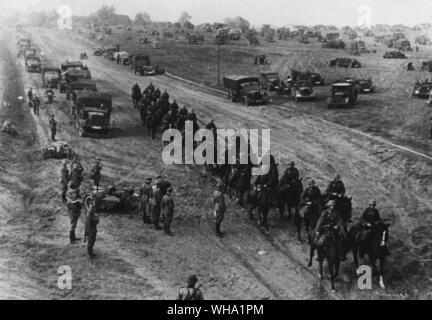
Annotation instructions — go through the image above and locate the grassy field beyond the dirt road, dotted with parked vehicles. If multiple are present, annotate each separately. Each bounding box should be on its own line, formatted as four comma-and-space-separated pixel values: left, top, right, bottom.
78, 29, 432, 151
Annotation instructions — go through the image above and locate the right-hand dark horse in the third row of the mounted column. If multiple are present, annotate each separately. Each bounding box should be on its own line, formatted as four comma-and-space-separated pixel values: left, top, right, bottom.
278, 179, 303, 224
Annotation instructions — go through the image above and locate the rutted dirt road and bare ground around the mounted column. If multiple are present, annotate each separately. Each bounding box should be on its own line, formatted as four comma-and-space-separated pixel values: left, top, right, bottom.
0, 29, 432, 299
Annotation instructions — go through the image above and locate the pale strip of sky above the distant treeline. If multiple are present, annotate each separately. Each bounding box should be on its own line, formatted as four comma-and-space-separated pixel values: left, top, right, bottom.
0, 0, 432, 26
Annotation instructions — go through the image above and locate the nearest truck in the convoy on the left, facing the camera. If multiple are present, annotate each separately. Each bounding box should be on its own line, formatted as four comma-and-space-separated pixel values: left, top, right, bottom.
75, 92, 112, 137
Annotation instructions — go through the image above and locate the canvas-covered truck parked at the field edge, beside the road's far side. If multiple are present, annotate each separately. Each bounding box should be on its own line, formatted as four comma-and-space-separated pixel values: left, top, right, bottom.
223, 75, 267, 106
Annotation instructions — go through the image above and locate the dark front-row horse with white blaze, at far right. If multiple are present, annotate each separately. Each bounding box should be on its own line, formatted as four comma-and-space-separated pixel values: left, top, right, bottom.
348, 222, 390, 290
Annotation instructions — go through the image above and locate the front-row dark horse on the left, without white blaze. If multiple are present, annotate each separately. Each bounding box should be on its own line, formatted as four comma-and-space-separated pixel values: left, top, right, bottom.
308, 225, 340, 292
